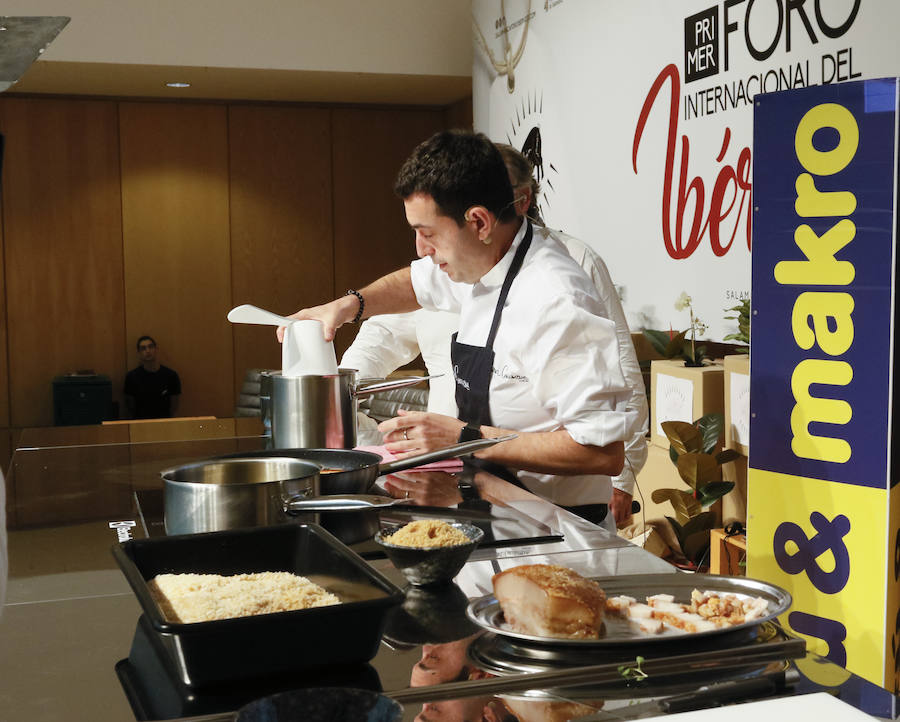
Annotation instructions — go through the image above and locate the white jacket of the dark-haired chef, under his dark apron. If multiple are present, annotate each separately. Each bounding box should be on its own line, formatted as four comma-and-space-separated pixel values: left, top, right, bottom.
410, 223, 636, 506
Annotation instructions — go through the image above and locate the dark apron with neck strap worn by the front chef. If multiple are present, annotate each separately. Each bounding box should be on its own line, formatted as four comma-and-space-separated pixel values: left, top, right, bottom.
450, 220, 607, 524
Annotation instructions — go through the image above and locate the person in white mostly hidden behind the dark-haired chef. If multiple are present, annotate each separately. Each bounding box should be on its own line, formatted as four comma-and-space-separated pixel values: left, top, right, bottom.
340, 143, 649, 524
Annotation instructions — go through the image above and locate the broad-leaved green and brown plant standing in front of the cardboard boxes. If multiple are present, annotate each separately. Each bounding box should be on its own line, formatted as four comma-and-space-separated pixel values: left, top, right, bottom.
651, 413, 740, 569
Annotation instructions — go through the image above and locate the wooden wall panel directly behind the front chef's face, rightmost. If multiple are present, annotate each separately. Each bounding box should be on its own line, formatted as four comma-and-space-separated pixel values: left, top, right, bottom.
332, 109, 445, 358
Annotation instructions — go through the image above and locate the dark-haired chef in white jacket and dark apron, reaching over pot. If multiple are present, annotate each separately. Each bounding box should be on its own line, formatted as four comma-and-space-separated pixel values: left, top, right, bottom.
279, 131, 634, 522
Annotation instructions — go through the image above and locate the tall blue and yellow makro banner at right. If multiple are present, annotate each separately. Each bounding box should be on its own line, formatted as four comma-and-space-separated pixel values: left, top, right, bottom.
748, 79, 900, 691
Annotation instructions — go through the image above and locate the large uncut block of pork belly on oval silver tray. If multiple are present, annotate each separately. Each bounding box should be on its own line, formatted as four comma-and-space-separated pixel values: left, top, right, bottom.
493, 564, 606, 639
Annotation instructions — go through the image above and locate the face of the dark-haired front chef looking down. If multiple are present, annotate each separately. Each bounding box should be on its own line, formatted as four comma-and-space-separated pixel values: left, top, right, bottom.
403, 193, 493, 283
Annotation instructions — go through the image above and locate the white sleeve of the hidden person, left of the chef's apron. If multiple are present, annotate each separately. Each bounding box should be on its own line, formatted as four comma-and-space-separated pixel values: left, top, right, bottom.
340, 309, 459, 416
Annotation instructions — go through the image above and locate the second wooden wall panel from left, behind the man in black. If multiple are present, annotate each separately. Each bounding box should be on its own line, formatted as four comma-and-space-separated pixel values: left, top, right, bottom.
119, 103, 234, 417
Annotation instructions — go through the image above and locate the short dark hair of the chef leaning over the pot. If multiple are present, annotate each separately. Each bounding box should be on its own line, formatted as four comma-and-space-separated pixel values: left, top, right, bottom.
394, 130, 516, 226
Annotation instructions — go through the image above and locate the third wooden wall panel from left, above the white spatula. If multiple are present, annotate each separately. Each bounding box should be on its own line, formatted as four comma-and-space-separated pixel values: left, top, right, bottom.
228, 106, 334, 400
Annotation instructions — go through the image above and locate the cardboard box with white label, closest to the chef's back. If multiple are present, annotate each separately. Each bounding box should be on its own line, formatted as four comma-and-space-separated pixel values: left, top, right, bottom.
650, 359, 725, 449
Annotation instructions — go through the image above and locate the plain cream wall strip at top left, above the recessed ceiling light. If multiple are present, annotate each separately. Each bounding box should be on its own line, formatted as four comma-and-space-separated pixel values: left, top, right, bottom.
2, 0, 472, 76
